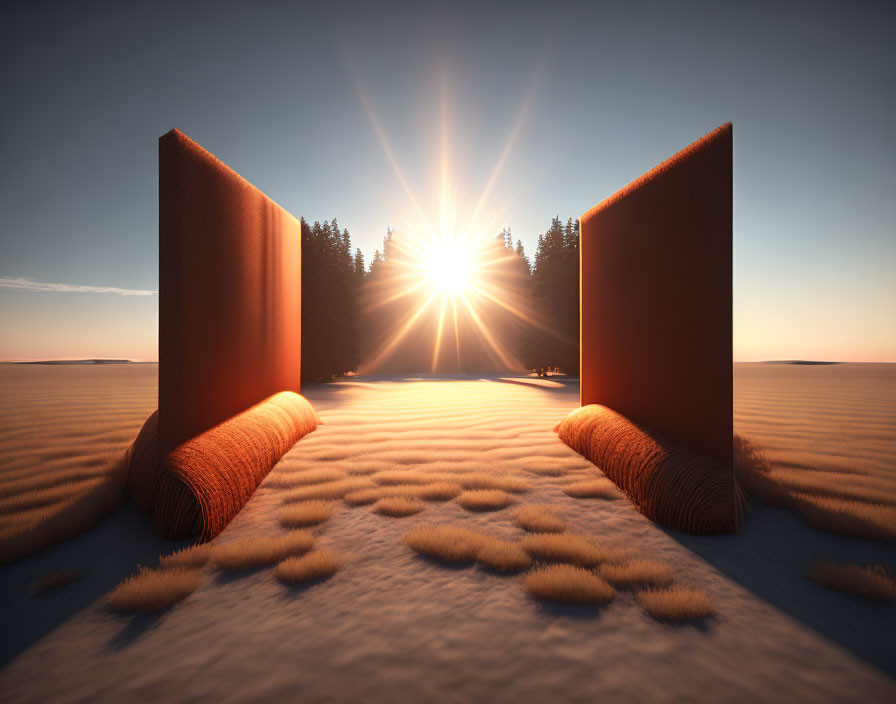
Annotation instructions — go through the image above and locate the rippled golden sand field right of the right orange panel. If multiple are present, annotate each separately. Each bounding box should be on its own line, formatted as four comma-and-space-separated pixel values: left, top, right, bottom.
734, 364, 896, 520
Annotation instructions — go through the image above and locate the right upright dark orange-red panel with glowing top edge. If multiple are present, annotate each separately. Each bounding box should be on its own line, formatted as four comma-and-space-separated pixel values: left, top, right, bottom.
580, 123, 732, 467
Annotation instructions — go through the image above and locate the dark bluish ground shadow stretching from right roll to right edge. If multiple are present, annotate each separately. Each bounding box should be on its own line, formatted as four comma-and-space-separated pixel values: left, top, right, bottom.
666, 501, 896, 677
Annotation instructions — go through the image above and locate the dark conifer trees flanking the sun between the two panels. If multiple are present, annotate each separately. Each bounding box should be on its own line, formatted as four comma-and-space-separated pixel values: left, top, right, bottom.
302, 217, 579, 381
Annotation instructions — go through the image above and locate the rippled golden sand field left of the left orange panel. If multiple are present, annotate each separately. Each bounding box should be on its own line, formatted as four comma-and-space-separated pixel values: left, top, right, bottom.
0, 364, 158, 534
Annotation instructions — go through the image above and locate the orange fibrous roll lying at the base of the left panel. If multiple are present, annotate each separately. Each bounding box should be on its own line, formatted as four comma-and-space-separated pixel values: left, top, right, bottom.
152, 391, 323, 540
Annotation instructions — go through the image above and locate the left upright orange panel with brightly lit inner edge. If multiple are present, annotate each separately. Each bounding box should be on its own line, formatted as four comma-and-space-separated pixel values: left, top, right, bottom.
159, 130, 302, 454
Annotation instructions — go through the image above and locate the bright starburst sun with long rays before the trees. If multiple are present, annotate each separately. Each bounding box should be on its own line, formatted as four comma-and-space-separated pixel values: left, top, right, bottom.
355, 68, 537, 371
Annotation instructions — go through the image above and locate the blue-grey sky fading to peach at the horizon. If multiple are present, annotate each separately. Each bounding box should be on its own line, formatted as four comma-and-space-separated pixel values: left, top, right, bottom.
0, 2, 896, 361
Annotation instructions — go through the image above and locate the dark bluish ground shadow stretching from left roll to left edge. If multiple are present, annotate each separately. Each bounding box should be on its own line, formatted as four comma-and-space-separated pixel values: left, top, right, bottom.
0, 504, 185, 667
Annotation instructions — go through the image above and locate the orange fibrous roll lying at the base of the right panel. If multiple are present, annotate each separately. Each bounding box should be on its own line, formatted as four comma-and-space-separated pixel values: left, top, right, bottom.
557, 404, 747, 535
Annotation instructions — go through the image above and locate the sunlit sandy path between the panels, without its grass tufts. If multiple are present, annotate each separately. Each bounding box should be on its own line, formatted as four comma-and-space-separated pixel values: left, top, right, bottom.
0, 372, 896, 702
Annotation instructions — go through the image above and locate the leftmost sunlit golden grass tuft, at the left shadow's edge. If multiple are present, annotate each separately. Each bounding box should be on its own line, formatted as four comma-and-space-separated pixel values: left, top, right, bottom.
106, 567, 202, 613
